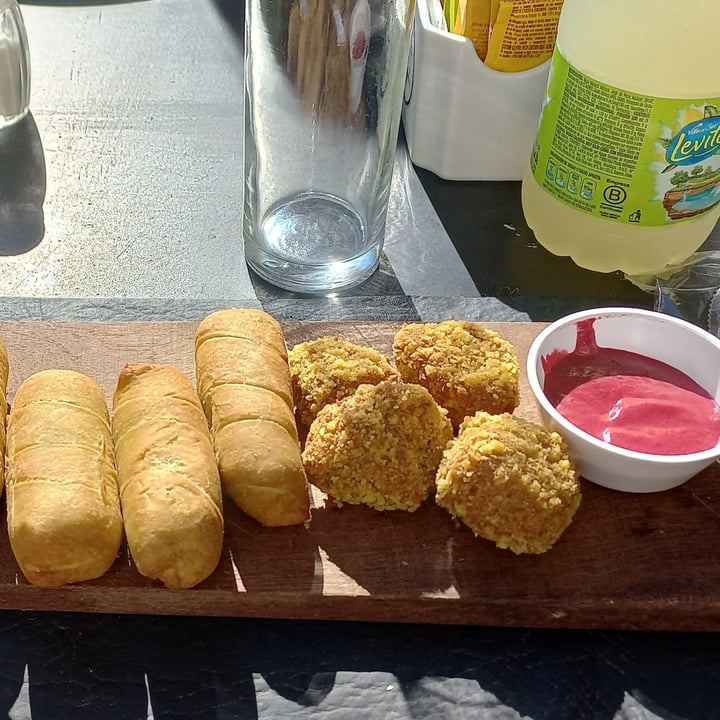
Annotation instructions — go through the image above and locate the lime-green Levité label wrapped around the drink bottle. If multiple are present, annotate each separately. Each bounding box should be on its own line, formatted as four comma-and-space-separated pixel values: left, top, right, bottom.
530, 49, 720, 227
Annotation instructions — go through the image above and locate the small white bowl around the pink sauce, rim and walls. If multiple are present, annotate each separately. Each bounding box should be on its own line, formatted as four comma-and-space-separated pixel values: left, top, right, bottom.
527, 308, 720, 492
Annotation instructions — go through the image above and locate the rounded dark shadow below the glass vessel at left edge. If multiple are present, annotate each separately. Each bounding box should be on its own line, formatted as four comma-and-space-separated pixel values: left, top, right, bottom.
0, 113, 46, 255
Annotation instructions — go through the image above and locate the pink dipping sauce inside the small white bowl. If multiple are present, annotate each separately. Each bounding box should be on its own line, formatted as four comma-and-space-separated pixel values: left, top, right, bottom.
542, 318, 720, 455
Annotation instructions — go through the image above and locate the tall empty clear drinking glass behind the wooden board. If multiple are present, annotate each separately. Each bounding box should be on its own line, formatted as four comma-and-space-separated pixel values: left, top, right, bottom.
243, 0, 415, 294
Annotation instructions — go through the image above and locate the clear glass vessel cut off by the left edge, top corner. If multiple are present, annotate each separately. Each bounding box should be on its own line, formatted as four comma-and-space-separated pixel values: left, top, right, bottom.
0, 0, 30, 128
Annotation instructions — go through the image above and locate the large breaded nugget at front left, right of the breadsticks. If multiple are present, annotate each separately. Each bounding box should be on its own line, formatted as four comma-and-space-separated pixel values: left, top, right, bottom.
303, 381, 452, 511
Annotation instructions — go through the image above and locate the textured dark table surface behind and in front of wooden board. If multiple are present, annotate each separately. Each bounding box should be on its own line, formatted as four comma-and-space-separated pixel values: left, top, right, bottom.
0, 0, 720, 720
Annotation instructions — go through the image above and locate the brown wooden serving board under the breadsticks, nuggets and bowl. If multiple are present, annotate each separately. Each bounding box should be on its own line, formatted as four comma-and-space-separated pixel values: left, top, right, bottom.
0, 322, 720, 630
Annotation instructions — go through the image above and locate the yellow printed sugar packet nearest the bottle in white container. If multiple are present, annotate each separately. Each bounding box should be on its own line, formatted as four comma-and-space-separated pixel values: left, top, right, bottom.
485, 0, 563, 72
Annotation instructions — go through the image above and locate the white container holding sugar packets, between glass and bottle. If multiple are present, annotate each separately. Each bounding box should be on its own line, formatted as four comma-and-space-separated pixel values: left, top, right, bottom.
402, 0, 550, 180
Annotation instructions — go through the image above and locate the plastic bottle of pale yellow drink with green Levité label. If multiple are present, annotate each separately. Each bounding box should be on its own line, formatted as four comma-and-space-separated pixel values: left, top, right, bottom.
522, 0, 720, 275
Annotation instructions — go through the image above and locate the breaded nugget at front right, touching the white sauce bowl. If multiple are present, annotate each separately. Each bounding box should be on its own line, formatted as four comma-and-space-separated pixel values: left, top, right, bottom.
435, 412, 581, 554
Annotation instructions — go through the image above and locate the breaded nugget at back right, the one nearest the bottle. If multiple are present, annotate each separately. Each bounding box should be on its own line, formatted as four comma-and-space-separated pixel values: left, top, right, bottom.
393, 320, 520, 429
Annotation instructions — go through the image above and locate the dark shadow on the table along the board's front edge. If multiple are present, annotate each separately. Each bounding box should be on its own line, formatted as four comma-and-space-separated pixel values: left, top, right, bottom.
0, 611, 720, 720
